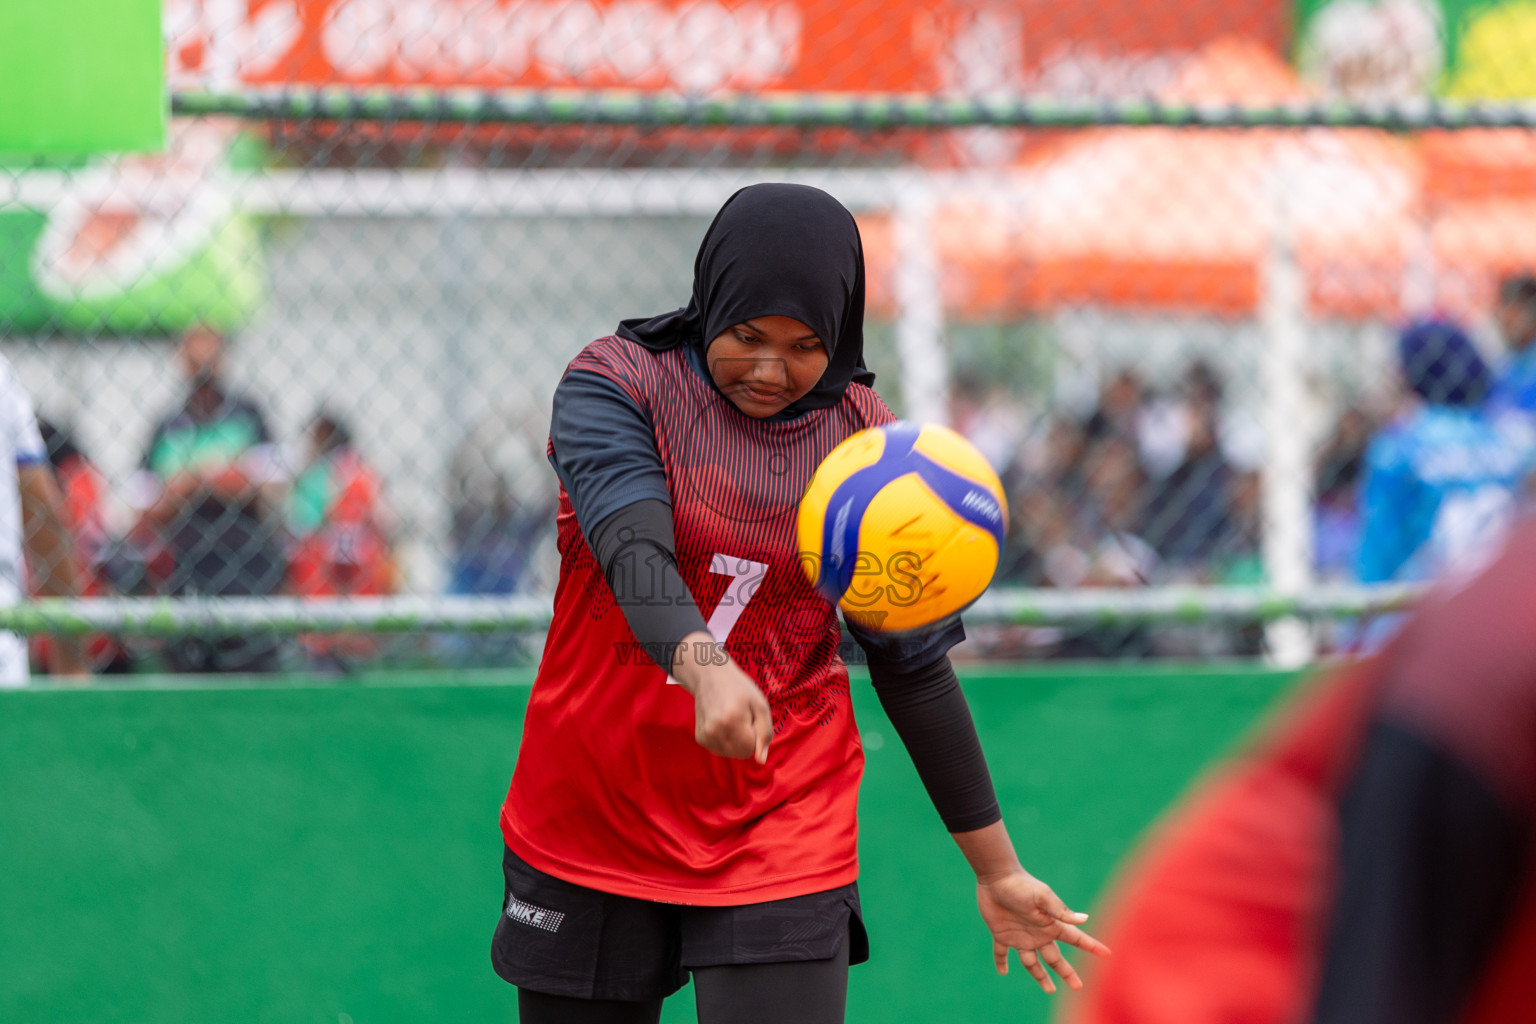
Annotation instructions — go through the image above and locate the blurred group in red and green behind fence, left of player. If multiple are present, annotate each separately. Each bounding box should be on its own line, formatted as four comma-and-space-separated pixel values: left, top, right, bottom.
34, 327, 395, 672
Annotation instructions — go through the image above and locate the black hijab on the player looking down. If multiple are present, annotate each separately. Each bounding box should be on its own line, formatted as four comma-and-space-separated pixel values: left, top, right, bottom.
619, 184, 874, 419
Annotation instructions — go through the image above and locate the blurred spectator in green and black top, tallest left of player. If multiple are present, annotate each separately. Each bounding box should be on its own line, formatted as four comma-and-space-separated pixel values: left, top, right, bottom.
138, 327, 286, 672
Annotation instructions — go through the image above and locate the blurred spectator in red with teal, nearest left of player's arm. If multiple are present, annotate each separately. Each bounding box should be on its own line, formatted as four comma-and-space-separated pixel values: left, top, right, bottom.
289, 411, 393, 597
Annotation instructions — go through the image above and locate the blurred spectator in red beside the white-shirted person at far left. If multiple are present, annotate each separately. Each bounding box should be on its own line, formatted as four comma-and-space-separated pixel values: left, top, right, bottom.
28, 416, 129, 672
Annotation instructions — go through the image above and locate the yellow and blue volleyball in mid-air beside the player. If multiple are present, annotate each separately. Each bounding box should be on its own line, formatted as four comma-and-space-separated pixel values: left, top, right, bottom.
799, 421, 1008, 633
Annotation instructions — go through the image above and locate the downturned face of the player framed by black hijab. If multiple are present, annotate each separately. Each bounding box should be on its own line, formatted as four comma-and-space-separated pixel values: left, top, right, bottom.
707, 316, 826, 419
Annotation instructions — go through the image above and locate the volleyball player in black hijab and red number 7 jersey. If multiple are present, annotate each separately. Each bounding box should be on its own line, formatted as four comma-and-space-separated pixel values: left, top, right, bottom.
492, 184, 1107, 1024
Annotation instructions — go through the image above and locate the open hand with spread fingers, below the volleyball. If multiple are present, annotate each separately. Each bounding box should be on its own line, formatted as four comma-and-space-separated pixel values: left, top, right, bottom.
975, 869, 1109, 992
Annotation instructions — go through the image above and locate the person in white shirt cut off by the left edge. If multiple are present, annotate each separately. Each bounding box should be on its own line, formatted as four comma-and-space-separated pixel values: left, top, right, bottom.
0, 363, 89, 686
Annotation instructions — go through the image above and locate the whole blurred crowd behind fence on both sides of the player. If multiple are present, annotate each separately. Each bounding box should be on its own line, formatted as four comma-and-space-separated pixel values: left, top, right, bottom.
35, 275, 1536, 671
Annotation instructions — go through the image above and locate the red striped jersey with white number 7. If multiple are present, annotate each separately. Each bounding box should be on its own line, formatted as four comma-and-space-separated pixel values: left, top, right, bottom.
501, 338, 894, 906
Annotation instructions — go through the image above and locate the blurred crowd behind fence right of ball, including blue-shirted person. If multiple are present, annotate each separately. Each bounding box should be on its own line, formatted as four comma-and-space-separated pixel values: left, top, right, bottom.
952, 275, 1536, 657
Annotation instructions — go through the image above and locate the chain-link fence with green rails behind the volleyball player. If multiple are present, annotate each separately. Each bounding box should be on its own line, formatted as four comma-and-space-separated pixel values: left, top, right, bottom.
0, 0, 1536, 669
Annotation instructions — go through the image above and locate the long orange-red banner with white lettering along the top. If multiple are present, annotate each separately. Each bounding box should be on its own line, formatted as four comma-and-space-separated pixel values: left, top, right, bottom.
164, 0, 1289, 95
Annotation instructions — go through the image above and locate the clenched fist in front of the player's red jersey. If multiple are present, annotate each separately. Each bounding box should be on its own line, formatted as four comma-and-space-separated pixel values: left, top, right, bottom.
673, 633, 773, 765
